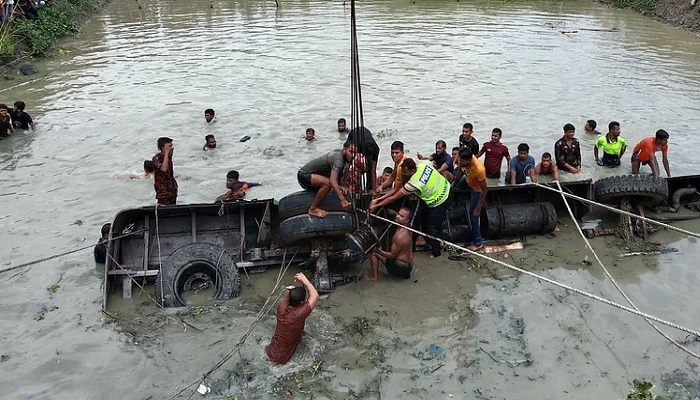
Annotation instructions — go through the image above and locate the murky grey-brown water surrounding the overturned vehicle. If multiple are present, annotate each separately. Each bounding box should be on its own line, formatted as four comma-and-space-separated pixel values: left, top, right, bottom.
0, 0, 700, 399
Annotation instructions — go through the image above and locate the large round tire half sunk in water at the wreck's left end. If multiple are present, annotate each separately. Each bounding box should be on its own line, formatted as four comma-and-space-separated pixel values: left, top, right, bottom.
156, 243, 241, 307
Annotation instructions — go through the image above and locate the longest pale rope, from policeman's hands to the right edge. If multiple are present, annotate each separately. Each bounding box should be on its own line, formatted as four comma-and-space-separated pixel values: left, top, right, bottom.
371, 209, 700, 336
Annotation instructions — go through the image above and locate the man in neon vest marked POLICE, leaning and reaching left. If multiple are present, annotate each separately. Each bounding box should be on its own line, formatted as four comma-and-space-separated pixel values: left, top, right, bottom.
369, 158, 450, 257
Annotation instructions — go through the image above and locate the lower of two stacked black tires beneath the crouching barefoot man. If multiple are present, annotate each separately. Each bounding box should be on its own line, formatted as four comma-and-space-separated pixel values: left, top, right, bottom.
279, 212, 355, 245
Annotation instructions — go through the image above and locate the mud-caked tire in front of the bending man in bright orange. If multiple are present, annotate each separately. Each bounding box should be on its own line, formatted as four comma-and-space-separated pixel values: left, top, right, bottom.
594, 175, 668, 205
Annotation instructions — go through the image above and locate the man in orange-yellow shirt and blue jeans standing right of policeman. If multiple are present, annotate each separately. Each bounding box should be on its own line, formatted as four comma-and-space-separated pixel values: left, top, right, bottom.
455, 147, 488, 251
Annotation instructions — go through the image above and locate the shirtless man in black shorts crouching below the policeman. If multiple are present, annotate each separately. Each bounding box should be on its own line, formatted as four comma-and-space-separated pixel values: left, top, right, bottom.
362, 207, 413, 282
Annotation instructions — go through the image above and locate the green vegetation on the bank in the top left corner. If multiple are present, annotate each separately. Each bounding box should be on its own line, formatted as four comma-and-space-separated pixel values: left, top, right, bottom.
0, 0, 94, 60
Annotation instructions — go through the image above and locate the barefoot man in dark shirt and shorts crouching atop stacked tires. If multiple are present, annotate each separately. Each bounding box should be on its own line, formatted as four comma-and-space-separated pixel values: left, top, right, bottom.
297, 141, 355, 218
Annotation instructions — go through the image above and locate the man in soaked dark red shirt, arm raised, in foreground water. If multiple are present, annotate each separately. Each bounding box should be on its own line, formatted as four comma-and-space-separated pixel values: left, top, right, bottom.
266, 272, 318, 364
